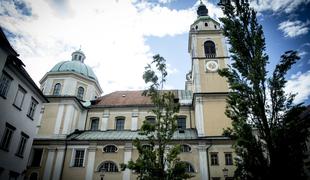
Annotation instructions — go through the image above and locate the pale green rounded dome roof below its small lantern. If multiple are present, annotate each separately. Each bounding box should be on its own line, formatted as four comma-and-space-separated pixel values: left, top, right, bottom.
50, 61, 98, 81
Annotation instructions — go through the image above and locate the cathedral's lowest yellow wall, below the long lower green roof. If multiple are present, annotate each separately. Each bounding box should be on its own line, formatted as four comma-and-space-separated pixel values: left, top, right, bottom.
27, 140, 235, 180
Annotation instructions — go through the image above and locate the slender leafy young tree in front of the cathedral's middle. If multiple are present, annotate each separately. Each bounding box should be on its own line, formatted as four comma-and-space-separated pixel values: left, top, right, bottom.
121, 55, 192, 180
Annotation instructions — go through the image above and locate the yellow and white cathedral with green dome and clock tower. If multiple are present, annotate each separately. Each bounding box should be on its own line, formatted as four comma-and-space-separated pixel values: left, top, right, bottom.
26, 4, 235, 180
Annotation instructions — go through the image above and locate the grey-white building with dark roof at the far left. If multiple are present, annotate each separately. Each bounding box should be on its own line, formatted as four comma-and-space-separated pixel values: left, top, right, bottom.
0, 28, 47, 179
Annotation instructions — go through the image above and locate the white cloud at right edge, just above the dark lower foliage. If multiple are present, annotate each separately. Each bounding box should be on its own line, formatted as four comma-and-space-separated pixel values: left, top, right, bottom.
285, 71, 310, 103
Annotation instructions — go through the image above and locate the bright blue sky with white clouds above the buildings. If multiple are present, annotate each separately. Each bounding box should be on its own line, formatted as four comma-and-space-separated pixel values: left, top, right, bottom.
0, 0, 310, 104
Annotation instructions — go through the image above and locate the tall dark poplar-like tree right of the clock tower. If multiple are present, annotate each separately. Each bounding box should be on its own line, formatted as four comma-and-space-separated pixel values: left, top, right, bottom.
219, 0, 310, 179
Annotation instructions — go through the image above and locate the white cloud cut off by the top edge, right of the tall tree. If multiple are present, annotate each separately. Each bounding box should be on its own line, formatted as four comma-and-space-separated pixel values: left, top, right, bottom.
250, 0, 310, 13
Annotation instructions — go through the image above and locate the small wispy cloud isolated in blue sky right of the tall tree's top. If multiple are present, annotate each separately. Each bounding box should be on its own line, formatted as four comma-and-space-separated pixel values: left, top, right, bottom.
278, 20, 309, 38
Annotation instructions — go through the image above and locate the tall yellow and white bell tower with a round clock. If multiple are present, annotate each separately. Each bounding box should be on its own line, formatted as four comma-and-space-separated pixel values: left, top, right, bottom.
186, 3, 231, 136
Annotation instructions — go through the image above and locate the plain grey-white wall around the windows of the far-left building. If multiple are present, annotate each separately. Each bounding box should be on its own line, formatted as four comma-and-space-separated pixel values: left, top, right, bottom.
0, 55, 45, 179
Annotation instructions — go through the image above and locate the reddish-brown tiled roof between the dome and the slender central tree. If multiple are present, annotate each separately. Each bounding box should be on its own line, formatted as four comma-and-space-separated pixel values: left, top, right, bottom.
95, 91, 152, 106
